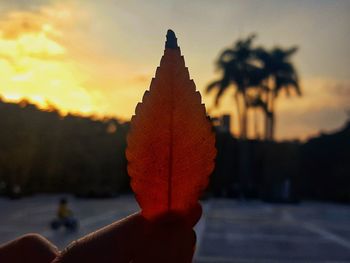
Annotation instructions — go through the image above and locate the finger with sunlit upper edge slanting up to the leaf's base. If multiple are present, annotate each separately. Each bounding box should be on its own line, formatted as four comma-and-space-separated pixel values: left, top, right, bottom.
53, 213, 144, 263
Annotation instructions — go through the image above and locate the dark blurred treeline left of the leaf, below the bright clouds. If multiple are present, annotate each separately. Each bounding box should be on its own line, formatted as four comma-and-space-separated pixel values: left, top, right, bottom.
0, 101, 128, 198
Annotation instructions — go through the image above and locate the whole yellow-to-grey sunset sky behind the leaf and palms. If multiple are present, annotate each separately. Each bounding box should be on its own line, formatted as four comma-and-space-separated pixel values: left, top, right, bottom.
0, 0, 350, 139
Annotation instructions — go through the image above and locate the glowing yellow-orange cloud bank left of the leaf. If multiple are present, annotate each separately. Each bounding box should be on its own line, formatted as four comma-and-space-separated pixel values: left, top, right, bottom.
0, 2, 152, 119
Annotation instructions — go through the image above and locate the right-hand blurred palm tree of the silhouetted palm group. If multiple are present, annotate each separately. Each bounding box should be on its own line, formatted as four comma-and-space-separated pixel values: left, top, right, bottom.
255, 47, 301, 140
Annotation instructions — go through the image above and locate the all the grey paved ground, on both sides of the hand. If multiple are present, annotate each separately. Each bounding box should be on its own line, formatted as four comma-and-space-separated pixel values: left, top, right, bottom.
0, 195, 350, 263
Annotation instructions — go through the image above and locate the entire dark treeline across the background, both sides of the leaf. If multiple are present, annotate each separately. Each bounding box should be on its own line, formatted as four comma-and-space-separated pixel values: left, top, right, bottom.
0, 100, 350, 202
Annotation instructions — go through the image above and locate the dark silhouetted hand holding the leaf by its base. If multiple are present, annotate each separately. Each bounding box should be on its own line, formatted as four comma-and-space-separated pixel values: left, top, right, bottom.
0, 207, 201, 263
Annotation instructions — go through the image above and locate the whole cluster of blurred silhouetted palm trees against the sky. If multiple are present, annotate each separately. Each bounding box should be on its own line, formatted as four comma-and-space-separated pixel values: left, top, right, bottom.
206, 35, 301, 140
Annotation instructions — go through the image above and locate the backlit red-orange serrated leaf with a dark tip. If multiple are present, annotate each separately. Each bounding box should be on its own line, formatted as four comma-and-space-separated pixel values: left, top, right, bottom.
126, 30, 216, 226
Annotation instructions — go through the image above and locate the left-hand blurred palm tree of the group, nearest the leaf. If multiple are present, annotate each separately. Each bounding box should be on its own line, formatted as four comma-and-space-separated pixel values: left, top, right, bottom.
206, 35, 259, 139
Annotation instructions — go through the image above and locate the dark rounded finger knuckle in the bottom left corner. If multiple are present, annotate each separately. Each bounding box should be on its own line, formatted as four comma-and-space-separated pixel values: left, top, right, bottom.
0, 234, 58, 263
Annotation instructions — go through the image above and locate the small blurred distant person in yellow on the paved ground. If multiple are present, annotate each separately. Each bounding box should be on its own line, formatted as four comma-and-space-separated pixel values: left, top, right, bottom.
51, 198, 78, 230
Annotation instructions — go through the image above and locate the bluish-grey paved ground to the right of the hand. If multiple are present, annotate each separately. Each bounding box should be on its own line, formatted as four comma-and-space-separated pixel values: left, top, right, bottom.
196, 200, 350, 263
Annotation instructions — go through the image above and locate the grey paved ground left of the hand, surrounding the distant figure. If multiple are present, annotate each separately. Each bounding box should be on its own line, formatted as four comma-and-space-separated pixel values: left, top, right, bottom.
0, 195, 138, 251
